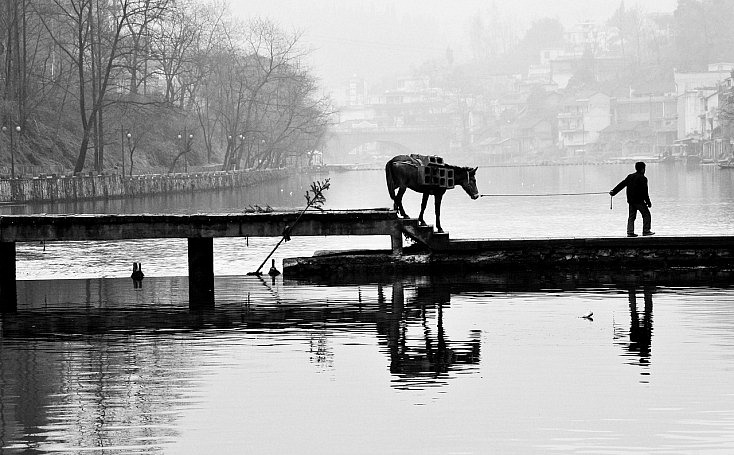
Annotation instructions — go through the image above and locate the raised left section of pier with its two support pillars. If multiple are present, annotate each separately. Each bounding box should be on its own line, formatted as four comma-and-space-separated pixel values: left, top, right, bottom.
0, 209, 402, 312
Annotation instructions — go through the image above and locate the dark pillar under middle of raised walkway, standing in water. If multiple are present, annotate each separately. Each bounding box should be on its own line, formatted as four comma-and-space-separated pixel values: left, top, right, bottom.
188, 237, 214, 310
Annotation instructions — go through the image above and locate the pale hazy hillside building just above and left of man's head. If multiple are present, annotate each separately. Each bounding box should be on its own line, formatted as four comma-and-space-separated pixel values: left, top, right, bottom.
557, 92, 611, 157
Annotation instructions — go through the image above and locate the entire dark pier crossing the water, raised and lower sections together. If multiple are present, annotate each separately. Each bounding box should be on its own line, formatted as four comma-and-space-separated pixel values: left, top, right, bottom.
0, 209, 734, 311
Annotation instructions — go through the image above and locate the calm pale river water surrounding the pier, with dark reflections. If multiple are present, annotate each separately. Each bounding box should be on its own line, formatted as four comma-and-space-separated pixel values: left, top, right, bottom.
0, 165, 734, 454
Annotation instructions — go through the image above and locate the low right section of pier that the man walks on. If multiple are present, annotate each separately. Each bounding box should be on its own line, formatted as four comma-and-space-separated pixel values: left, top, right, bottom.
283, 236, 734, 279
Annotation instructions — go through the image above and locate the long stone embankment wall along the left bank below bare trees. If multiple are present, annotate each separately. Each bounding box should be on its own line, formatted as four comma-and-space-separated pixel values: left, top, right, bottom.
0, 169, 290, 203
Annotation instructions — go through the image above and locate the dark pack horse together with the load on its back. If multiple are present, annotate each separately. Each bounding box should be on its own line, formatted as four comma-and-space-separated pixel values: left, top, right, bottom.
385, 154, 479, 232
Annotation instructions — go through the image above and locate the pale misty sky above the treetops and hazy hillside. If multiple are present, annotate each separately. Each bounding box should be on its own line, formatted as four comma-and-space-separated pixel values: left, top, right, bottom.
232, 0, 677, 95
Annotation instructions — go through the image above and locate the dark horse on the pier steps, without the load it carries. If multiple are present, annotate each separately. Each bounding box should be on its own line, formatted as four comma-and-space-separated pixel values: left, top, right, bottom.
385, 155, 479, 232
